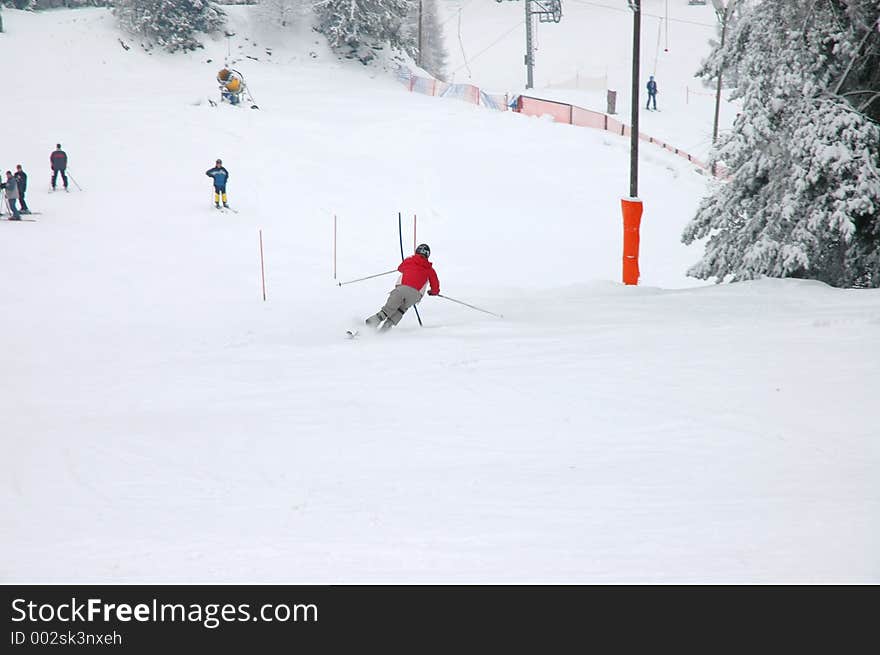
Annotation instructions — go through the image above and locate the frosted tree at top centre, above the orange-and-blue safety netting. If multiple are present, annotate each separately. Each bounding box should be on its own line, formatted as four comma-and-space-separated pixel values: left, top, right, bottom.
314, 0, 414, 62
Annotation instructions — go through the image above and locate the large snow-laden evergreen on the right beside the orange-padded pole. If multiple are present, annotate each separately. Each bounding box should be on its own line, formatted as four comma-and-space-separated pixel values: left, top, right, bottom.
683, 0, 880, 287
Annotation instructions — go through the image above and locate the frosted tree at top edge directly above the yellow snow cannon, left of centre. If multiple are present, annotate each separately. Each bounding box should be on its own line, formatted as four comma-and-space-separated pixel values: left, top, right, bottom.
113, 0, 226, 52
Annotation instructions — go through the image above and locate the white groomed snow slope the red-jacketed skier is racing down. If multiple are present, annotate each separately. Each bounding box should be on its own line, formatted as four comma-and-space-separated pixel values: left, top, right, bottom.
0, 3, 880, 584
